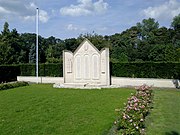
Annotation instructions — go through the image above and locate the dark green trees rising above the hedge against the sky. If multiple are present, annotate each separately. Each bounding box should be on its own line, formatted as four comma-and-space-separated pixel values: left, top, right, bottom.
0, 14, 180, 65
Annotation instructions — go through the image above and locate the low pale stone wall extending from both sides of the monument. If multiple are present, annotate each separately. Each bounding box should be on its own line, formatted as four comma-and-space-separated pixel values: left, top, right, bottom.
17, 76, 179, 88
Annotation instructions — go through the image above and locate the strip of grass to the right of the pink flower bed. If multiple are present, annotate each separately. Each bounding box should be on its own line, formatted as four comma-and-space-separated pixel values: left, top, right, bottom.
147, 89, 180, 135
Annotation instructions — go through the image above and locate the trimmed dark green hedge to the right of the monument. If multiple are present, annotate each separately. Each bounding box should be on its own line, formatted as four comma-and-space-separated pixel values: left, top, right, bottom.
111, 62, 180, 79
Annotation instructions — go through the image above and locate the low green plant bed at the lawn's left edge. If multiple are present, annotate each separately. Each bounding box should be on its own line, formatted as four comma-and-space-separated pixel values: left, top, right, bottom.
0, 82, 29, 90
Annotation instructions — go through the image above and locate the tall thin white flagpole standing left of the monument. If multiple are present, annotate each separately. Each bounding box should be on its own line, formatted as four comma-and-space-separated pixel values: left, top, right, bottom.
36, 8, 39, 83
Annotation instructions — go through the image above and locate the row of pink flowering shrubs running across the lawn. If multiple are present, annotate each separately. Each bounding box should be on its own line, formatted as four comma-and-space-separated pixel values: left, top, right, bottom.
114, 85, 153, 135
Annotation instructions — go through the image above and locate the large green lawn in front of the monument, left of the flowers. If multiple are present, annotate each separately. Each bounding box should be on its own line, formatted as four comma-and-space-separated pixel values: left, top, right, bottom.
0, 84, 134, 135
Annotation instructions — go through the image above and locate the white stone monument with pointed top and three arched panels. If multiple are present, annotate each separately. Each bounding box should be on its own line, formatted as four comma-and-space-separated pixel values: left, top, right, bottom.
63, 39, 110, 87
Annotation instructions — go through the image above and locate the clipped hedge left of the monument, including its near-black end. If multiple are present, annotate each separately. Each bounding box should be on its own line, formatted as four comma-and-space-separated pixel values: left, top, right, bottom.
0, 63, 63, 83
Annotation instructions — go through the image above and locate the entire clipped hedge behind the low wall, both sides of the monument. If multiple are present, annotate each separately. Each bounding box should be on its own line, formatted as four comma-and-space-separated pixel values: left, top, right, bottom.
0, 62, 180, 83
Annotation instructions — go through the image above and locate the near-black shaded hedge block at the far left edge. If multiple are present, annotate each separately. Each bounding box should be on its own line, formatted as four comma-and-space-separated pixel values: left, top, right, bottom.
0, 65, 20, 83
